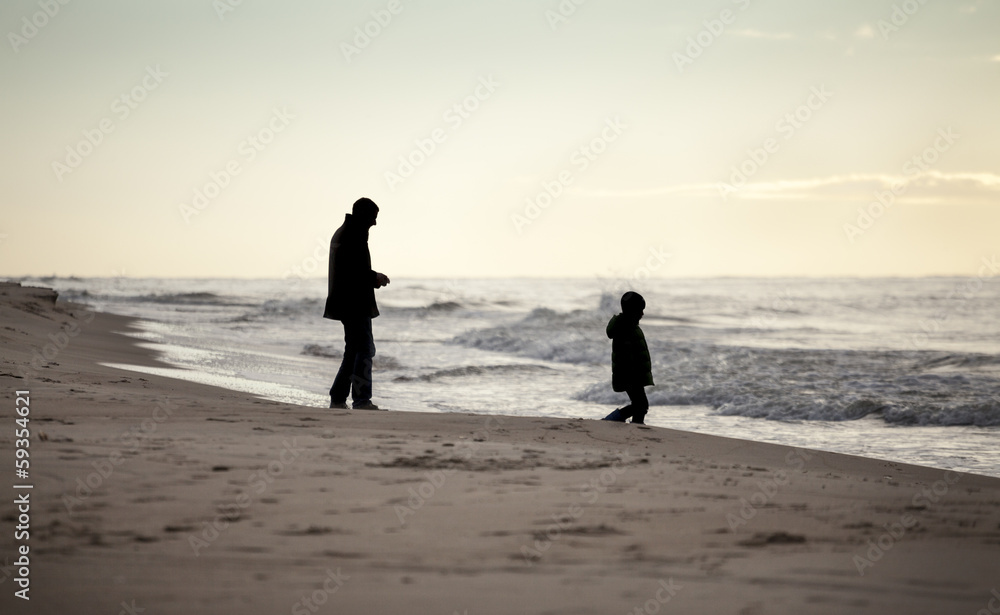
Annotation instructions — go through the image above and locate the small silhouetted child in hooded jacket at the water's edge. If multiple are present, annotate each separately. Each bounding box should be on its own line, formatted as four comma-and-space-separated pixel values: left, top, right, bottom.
604, 291, 653, 425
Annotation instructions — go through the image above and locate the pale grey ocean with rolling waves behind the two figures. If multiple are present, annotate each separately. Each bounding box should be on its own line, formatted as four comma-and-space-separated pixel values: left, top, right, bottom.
20, 277, 1000, 476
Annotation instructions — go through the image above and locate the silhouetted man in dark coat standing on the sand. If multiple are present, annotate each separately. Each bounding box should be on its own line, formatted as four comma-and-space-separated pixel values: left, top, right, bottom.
323, 198, 389, 410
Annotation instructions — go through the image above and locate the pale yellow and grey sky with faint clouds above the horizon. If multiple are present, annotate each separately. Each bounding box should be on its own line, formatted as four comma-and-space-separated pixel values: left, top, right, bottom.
0, 0, 1000, 278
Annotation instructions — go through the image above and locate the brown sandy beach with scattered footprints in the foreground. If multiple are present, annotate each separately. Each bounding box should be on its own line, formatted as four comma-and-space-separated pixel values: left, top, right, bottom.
0, 284, 1000, 615
